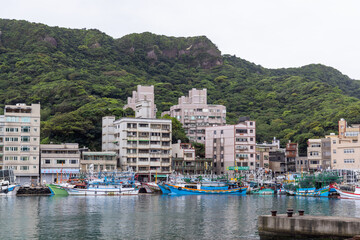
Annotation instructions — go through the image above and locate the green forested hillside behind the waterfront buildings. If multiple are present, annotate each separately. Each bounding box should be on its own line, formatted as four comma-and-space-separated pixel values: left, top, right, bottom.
0, 19, 360, 152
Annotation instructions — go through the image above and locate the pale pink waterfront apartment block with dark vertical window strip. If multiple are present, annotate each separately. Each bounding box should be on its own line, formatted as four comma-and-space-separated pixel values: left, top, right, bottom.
205, 118, 256, 174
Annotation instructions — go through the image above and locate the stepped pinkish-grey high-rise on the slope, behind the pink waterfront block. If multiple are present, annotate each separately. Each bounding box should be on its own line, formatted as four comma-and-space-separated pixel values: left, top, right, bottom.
165, 88, 226, 144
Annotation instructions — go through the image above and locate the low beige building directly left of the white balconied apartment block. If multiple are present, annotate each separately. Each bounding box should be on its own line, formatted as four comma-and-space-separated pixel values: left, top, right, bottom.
80, 152, 117, 173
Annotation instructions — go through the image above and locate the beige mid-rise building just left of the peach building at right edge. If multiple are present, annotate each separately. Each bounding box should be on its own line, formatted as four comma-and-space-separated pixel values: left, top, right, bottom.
307, 138, 331, 171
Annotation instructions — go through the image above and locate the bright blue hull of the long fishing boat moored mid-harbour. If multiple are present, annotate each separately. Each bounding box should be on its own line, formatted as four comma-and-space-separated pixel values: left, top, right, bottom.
164, 184, 247, 195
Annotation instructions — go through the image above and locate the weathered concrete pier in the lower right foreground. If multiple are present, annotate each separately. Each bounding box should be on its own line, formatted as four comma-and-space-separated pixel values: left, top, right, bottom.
258, 214, 360, 239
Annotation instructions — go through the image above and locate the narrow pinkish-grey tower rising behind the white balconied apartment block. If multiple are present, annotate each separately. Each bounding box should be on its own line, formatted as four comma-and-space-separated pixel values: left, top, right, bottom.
124, 85, 157, 118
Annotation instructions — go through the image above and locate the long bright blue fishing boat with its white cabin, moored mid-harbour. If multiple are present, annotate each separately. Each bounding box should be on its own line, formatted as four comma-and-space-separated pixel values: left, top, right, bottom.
164, 183, 247, 195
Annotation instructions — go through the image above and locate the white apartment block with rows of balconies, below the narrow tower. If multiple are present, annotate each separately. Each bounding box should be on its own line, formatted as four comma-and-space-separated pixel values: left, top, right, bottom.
103, 117, 172, 178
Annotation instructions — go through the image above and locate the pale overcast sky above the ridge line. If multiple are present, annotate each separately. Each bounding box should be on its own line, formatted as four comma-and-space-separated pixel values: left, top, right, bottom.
0, 0, 360, 80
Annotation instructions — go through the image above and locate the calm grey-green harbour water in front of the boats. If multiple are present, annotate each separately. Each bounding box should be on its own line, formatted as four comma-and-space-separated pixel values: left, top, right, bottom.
0, 195, 360, 239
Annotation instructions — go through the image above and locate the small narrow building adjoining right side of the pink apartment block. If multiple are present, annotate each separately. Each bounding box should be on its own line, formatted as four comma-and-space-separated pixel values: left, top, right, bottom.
256, 137, 280, 170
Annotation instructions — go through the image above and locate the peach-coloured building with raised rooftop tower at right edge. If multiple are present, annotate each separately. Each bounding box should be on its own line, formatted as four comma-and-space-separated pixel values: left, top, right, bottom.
326, 119, 360, 170
